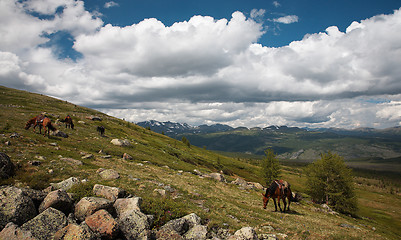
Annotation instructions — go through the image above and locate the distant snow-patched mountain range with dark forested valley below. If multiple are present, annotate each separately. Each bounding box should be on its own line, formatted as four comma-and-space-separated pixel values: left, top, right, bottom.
137, 120, 401, 160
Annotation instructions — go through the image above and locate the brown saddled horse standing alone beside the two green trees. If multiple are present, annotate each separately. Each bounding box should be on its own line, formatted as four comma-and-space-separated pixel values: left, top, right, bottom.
262, 180, 292, 212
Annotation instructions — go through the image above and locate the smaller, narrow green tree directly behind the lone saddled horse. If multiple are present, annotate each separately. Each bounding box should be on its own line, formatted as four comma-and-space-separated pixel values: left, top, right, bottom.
260, 149, 281, 186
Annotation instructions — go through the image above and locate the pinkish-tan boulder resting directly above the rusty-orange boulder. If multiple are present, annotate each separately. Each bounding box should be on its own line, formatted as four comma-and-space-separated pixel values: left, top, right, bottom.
74, 197, 113, 221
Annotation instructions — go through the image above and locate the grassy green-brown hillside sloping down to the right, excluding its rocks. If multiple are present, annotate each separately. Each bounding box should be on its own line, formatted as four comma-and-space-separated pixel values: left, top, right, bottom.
0, 87, 401, 239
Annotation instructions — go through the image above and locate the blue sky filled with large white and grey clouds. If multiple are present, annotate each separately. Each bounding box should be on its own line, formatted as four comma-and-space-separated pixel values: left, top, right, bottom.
0, 0, 401, 128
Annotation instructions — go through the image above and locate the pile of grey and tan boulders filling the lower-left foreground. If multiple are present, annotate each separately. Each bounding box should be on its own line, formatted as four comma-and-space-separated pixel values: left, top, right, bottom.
0, 153, 276, 240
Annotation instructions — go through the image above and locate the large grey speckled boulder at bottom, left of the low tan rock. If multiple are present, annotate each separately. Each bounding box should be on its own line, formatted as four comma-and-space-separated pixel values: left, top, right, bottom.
21, 208, 67, 240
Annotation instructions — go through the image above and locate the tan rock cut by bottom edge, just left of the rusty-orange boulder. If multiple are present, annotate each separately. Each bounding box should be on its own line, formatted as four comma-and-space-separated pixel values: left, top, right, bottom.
54, 223, 95, 240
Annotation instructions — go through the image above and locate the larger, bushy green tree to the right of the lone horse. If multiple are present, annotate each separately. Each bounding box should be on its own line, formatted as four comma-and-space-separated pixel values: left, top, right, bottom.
306, 152, 357, 214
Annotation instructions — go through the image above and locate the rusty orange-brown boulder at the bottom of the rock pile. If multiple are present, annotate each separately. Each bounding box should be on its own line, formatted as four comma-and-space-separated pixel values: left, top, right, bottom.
85, 209, 119, 239
